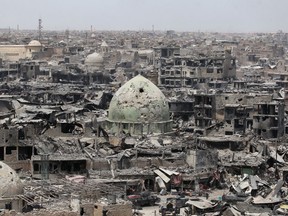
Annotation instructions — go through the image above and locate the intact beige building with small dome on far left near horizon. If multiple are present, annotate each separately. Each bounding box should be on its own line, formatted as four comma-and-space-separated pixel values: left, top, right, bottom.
0, 40, 42, 62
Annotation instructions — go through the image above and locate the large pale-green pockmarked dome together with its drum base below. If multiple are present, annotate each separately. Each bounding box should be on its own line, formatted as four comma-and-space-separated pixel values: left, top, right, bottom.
107, 75, 172, 135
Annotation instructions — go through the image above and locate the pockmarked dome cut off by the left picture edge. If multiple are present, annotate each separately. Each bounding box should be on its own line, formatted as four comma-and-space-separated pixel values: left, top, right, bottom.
0, 162, 23, 197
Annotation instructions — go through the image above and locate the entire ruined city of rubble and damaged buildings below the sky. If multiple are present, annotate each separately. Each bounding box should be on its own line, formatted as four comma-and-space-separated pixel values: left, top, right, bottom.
0, 26, 288, 216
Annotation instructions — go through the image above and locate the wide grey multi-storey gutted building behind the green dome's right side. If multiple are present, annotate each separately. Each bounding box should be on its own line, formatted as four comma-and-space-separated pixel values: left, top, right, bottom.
154, 48, 236, 88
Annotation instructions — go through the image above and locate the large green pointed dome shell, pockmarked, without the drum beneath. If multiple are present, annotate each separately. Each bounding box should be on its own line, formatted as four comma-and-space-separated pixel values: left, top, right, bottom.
108, 75, 170, 123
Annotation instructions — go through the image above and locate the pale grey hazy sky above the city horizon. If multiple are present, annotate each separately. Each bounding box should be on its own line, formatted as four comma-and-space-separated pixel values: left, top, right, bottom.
0, 0, 288, 32
